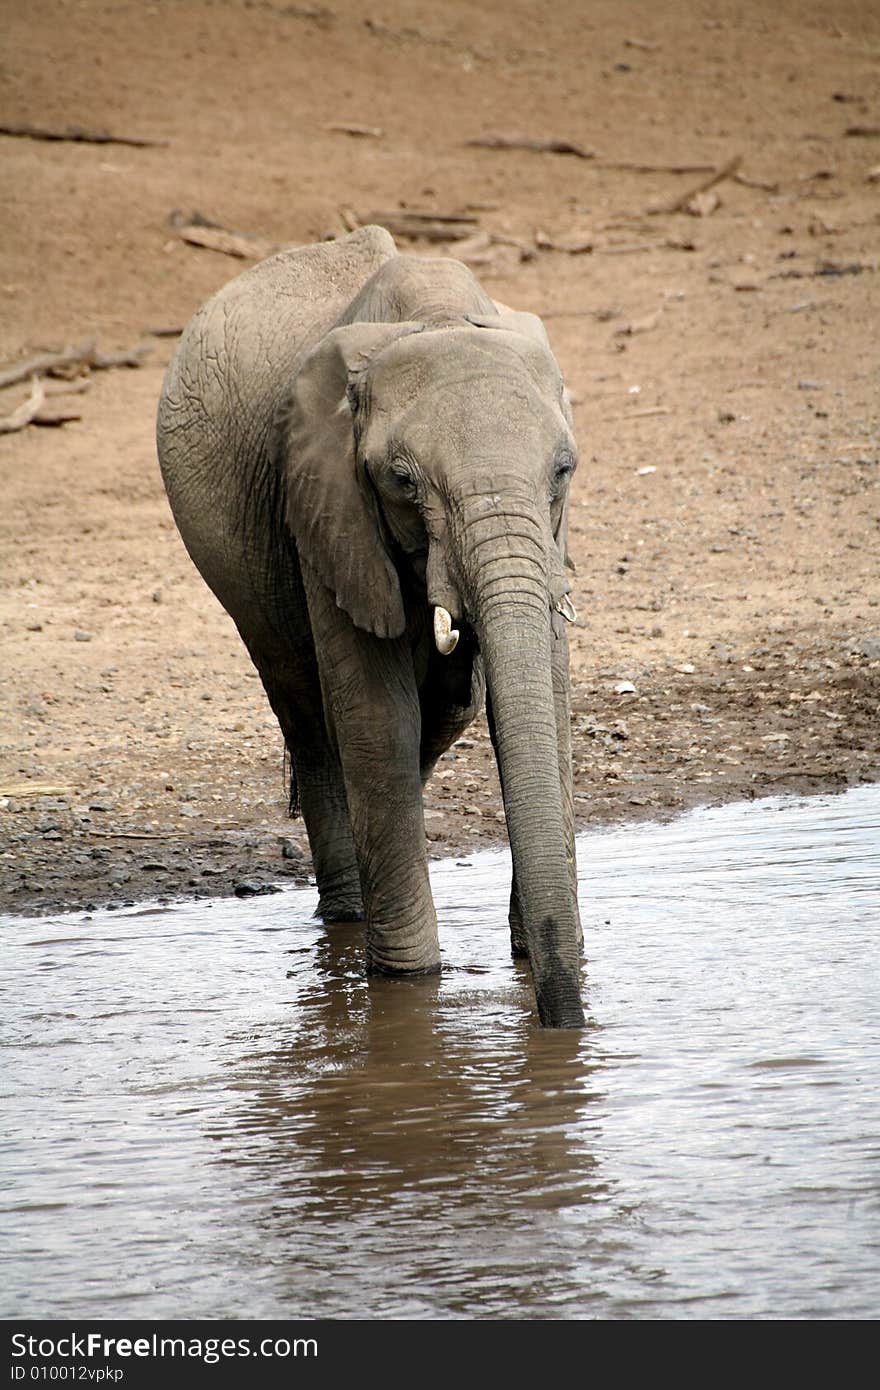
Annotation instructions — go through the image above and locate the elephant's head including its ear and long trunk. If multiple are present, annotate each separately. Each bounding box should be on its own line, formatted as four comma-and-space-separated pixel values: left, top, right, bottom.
279, 290, 584, 1027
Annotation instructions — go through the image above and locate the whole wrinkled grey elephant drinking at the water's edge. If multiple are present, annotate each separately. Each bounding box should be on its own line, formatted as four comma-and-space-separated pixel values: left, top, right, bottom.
158, 227, 584, 1027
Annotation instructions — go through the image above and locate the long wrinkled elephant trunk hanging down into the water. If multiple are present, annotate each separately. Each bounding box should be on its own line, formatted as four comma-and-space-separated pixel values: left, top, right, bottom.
453, 494, 584, 1029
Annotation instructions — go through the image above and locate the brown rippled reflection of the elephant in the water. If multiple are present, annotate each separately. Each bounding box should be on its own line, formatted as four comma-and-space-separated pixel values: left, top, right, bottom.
217, 927, 608, 1298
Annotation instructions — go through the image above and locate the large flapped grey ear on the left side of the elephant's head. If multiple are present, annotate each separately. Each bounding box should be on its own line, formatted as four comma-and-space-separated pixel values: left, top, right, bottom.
279, 324, 421, 637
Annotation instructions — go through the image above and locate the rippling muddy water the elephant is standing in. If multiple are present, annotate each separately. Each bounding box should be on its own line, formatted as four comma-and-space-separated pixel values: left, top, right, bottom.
0, 787, 880, 1318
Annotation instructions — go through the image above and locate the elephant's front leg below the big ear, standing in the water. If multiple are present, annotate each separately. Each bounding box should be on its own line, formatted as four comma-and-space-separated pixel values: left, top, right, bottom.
307, 577, 439, 974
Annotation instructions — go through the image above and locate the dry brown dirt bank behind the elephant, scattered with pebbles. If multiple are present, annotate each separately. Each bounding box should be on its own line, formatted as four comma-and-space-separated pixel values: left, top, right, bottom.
0, 0, 880, 912
